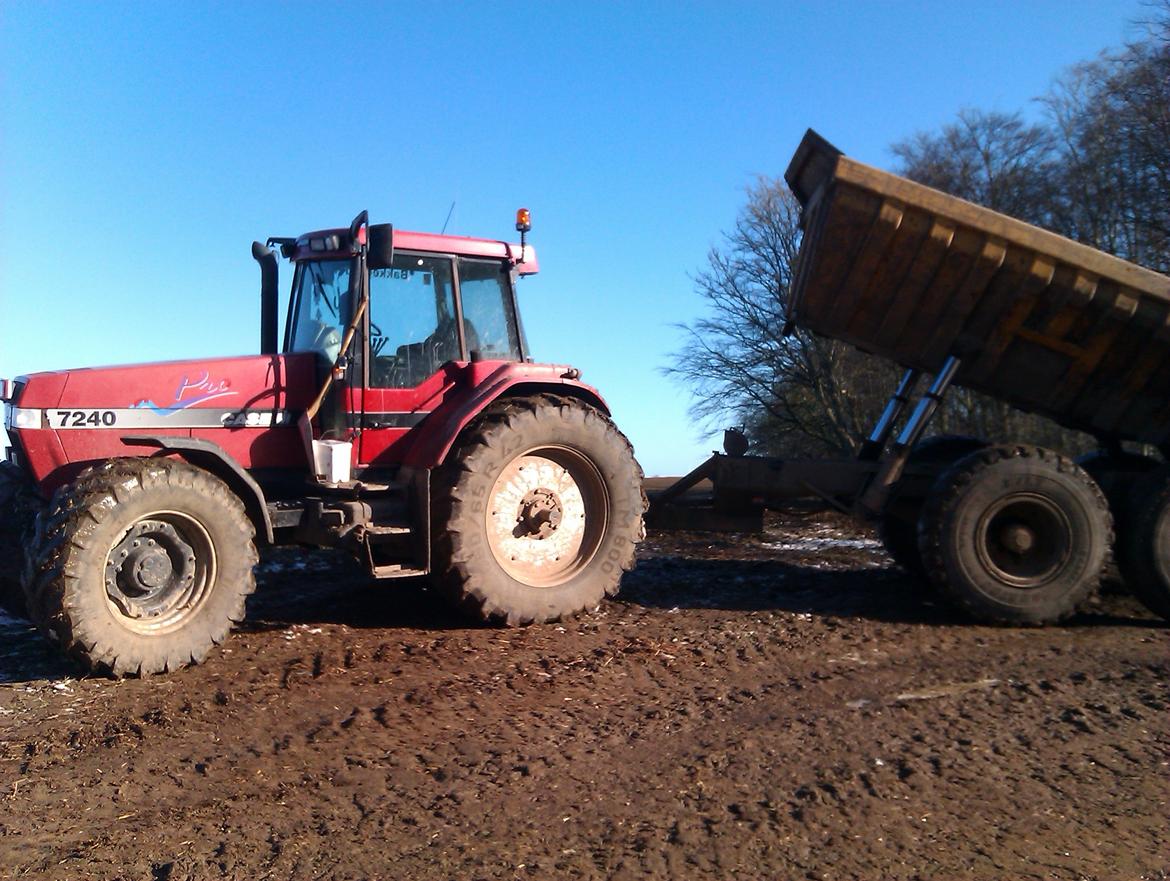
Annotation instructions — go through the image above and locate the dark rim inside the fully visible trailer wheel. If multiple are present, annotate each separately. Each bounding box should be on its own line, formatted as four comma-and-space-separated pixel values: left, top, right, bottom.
976, 493, 1073, 589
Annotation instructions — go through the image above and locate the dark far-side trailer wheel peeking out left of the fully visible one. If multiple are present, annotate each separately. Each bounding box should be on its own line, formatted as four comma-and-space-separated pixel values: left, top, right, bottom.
878, 434, 989, 577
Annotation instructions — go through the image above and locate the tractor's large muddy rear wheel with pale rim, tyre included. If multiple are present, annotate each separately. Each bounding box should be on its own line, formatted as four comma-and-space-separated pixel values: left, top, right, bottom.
432, 394, 646, 626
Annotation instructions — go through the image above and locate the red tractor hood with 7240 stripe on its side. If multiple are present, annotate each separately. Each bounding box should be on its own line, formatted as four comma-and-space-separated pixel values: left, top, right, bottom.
14, 355, 315, 433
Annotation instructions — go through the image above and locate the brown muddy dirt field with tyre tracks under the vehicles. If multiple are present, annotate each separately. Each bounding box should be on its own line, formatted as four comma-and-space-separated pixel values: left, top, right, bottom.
0, 518, 1170, 881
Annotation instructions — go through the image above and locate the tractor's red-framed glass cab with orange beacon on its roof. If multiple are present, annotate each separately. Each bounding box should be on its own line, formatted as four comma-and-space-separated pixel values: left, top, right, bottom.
257, 209, 538, 482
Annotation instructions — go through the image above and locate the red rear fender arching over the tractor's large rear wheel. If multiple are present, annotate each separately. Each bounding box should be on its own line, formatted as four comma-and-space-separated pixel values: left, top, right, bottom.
402, 362, 610, 469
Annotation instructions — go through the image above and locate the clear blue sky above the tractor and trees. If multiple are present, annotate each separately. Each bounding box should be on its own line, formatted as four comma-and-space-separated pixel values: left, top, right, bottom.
0, 0, 1143, 474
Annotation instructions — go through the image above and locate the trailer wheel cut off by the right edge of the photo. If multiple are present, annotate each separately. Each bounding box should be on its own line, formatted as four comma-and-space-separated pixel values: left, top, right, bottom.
1117, 466, 1170, 620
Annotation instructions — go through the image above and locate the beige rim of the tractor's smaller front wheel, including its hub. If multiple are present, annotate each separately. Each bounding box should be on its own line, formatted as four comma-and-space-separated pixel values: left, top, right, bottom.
105, 511, 216, 635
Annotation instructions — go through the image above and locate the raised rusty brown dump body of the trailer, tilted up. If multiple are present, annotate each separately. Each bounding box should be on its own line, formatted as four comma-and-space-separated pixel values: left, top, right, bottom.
785, 132, 1170, 447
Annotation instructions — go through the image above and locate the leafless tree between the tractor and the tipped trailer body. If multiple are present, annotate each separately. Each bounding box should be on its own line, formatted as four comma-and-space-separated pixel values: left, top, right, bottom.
665, 178, 888, 454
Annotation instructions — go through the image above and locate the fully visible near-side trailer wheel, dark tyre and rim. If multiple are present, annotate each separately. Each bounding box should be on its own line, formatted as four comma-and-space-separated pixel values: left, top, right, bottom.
920, 446, 1113, 625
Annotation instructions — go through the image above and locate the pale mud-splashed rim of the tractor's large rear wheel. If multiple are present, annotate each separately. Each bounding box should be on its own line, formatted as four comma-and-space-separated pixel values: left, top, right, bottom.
487, 447, 610, 587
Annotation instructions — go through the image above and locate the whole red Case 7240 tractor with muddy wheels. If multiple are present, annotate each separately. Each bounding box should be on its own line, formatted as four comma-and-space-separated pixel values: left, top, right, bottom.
0, 211, 646, 675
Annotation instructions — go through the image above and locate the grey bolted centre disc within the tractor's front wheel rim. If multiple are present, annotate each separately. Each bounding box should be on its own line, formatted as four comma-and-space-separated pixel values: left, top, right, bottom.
105, 519, 195, 619
